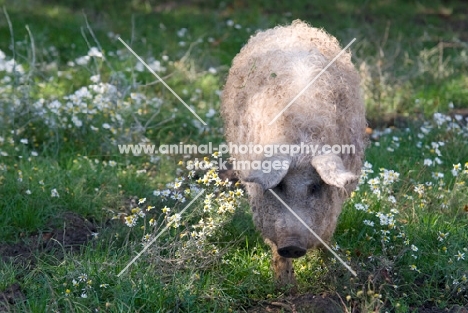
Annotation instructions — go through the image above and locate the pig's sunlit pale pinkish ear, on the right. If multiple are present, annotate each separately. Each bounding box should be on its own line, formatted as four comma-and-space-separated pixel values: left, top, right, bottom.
311, 153, 359, 188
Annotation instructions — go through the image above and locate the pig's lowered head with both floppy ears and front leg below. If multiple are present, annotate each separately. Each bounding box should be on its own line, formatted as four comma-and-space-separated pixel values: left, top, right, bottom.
242, 154, 358, 285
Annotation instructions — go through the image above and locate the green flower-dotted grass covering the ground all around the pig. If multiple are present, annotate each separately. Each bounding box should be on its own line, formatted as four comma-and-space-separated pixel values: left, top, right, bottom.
0, 0, 468, 312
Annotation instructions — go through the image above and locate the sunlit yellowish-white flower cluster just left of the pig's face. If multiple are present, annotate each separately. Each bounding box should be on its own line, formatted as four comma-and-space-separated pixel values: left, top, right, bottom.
114, 157, 244, 266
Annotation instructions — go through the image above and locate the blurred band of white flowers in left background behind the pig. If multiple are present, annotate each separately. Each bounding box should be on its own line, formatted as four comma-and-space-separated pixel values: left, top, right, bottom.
0, 40, 220, 156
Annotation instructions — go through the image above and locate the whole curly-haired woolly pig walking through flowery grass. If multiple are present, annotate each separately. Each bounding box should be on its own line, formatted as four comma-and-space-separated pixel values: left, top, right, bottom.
221, 20, 366, 286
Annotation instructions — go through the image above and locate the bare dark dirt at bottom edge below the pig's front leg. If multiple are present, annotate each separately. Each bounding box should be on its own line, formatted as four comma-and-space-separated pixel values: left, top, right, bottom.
247, 294, 345, 313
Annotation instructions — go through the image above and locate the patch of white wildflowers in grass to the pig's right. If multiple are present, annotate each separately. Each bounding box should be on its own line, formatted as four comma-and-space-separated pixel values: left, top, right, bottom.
345, 109, 468, 302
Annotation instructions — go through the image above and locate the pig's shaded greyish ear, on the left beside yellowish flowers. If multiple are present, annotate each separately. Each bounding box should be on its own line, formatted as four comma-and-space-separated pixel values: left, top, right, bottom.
242, 155, 290, 191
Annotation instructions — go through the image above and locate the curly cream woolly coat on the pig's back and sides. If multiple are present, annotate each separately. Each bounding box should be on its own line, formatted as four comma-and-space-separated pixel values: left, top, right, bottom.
221, 20, 366, 180
